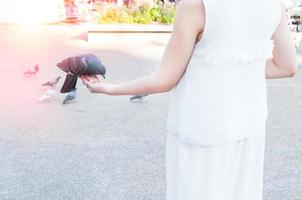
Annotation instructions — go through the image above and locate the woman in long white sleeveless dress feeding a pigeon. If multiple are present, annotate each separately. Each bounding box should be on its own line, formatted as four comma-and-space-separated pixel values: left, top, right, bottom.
82, 0, 297, 200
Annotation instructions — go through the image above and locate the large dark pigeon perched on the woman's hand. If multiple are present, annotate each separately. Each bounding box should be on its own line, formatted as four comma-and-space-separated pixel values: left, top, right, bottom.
57, 54, 106, 93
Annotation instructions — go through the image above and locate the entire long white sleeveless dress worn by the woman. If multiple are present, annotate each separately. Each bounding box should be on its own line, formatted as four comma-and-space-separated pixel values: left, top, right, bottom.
166, 0, 282, 200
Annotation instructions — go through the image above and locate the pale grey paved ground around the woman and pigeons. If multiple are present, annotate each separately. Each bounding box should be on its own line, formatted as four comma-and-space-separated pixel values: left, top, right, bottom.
0, 27, 302, 200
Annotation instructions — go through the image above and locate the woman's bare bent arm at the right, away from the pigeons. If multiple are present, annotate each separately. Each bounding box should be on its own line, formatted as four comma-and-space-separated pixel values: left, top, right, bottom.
266, 6, 298, 79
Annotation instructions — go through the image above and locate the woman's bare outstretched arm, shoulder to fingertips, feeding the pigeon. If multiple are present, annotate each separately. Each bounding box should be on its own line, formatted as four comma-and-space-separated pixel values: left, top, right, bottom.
84, 0, 205, 95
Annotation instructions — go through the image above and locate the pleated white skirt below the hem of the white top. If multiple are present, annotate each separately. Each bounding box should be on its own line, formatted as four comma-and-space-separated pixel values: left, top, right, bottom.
166, 129, 265, 200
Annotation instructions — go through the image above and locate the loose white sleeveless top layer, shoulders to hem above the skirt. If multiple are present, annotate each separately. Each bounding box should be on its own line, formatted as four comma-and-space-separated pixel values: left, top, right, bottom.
167, 0, 281, 146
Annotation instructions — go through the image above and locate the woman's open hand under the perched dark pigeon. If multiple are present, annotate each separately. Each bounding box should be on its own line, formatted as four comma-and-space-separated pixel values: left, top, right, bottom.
80, 75, 114, 95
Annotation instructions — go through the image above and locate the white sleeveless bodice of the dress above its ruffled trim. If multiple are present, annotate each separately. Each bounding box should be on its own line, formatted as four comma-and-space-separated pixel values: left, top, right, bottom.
194, 0, 281, 62
